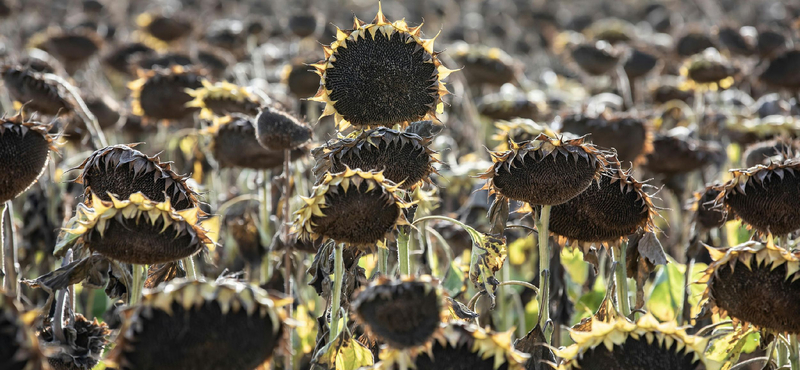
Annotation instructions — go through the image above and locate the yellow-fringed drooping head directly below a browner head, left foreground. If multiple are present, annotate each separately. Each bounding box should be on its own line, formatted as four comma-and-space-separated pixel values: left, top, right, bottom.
56, 193, 213, 264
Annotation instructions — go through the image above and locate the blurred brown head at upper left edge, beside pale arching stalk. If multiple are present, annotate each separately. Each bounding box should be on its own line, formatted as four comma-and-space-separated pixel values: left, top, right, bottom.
0, 65, 72, 116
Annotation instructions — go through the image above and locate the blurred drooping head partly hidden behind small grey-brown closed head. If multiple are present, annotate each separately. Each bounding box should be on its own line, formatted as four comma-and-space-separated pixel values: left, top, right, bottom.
206, 114, 308, 170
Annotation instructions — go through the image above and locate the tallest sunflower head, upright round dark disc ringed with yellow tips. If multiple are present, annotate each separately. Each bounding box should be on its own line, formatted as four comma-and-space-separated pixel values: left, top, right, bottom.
310, 4, 452, 129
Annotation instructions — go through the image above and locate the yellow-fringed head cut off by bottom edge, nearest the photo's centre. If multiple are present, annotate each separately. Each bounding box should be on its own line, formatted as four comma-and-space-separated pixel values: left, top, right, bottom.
374, 321, 528, 370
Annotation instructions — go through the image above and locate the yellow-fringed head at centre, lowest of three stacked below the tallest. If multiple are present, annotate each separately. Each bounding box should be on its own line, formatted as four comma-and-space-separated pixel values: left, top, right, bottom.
294, 167, 411, 250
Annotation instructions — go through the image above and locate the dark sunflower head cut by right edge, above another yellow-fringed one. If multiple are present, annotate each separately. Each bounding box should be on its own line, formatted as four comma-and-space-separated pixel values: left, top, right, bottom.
716, 158, 800, 236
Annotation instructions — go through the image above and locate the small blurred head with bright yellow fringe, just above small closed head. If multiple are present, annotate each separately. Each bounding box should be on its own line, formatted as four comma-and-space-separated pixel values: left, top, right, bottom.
186, 80, 260, 121
